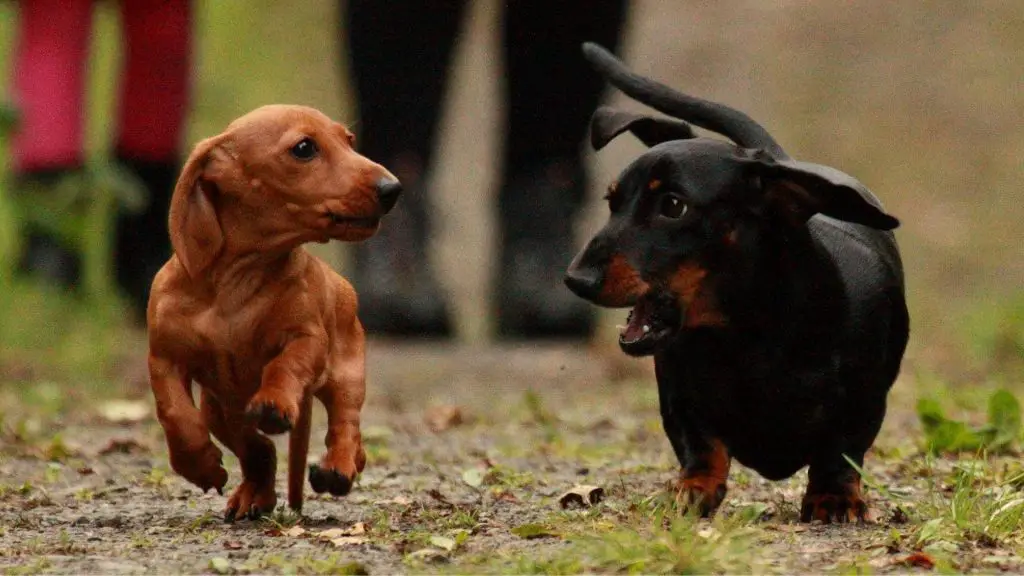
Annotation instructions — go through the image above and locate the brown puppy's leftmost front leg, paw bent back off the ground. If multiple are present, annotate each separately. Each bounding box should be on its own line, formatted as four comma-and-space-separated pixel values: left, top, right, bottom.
150, 355, 227, 492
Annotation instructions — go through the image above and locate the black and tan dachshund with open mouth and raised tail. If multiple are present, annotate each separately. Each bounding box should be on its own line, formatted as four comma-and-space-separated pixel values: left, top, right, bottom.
565, 44, 909, 522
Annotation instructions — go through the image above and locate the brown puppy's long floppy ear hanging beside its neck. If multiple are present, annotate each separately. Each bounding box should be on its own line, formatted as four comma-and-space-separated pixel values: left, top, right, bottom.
168, 134, 231, 278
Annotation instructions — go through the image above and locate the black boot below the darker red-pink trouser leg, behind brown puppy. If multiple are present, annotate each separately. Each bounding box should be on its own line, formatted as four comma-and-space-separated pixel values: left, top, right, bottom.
114, 156, 178, 321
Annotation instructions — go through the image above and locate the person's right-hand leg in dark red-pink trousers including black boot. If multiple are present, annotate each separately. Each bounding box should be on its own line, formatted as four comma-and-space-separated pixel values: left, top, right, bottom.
114, 0, 191, 314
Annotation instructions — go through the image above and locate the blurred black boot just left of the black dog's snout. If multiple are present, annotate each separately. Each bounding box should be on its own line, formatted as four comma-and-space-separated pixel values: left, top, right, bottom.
495, 161, 594, 339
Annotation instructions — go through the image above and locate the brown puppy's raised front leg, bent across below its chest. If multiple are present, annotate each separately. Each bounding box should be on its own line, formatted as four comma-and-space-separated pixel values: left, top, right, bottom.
246, 335, 327, 434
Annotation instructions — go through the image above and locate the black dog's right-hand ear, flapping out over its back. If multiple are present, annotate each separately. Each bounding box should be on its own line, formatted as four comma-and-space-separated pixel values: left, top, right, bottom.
757, 157, 899, 230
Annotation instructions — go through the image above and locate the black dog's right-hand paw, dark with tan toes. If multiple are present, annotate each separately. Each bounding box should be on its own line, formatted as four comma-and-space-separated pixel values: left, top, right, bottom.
800, 455, 867, 524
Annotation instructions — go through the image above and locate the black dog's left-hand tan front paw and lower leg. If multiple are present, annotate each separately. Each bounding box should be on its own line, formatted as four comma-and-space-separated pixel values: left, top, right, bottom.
676, 439, 732, 518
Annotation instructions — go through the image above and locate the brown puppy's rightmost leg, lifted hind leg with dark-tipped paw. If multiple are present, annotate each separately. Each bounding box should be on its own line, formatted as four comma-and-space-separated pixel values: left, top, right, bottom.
309, 320, 367, 496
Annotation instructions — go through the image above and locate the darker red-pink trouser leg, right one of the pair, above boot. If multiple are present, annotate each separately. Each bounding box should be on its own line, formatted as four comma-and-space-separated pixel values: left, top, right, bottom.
116, 0, 191, 163
